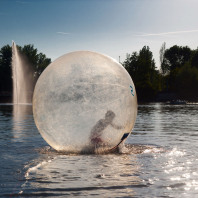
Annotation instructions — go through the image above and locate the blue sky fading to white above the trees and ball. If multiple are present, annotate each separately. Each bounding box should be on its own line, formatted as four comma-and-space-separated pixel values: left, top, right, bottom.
0, 0, 198, 68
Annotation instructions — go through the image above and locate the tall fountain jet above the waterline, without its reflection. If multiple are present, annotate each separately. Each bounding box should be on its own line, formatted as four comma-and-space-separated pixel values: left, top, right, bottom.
12, 41, 34, 104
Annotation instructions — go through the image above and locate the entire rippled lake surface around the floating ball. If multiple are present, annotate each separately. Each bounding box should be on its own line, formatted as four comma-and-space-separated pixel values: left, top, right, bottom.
0, 103, 198, 198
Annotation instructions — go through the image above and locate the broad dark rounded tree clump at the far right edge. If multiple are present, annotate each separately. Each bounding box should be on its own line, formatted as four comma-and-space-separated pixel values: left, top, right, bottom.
161, 45, 198, 100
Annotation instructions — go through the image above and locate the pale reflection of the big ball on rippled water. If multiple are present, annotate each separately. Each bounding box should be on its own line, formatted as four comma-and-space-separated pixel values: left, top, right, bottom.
23, 152, 141, 197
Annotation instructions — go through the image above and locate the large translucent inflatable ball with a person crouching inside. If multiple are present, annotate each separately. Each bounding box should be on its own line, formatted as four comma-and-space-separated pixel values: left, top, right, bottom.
33, 51, 137, 152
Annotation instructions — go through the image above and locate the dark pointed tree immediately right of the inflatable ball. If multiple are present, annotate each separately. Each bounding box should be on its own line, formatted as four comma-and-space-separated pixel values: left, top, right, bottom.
123, 46, 160, 101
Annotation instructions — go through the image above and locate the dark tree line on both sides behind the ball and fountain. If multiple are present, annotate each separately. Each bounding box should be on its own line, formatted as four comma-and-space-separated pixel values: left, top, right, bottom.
0, 43, 198, 101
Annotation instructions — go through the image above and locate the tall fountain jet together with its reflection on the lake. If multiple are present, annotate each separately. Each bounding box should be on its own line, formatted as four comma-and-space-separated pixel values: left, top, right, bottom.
12, 41, 34, 139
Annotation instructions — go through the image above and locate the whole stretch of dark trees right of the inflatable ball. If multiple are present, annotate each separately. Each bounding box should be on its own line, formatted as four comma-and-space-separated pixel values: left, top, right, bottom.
122, 43, 198, 101
